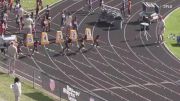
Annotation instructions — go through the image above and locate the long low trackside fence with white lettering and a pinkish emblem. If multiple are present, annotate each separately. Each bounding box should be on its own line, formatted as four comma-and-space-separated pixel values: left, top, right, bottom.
0, 56, 105, 101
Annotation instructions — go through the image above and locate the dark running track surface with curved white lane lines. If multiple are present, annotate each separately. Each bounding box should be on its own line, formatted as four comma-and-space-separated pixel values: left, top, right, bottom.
1, 0, 180, 101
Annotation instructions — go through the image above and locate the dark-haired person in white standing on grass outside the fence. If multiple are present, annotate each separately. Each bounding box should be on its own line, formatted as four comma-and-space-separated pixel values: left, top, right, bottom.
12, 77, 22, 101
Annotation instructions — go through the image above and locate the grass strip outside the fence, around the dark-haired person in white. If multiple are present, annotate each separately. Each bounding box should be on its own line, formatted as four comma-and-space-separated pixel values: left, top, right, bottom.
0, 72, 55, 101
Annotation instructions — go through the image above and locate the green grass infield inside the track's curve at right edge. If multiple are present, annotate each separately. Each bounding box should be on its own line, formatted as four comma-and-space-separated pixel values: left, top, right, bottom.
164, 8, 180, 59
